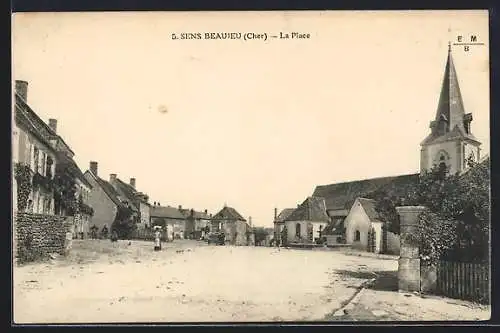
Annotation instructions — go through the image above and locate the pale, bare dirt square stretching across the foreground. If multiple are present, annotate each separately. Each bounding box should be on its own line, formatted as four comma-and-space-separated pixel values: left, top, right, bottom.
14, 240, 397, 323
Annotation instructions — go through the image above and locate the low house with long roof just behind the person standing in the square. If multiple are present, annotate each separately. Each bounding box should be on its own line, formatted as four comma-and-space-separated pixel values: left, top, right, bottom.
149, 202, 186, 239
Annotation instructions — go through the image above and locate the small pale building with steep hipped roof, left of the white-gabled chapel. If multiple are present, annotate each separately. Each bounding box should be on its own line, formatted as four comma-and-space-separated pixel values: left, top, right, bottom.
282, 196, 330, 245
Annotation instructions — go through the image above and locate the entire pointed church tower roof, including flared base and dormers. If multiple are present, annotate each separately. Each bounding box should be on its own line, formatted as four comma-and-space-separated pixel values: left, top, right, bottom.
421, 46, 478, 145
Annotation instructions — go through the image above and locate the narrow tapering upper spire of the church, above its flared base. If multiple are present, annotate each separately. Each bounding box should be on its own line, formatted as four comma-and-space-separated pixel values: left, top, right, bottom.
433, 42, 465, 135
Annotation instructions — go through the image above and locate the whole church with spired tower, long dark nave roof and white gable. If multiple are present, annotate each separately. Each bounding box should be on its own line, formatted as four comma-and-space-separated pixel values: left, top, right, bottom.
302, 44, 481, 254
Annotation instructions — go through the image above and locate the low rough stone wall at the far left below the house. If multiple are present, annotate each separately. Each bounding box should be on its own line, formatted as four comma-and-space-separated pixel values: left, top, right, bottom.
15, 212, 73, 263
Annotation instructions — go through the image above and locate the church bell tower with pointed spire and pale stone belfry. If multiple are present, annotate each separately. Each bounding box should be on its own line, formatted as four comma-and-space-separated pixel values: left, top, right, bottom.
420, 43, 481, 174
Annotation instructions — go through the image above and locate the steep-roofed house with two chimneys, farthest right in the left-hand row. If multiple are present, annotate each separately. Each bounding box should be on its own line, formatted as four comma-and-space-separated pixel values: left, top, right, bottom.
109, 174, 151, 229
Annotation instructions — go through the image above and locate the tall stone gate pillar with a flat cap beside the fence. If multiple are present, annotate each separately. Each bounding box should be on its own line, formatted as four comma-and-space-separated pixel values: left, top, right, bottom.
396, 206, 426, 292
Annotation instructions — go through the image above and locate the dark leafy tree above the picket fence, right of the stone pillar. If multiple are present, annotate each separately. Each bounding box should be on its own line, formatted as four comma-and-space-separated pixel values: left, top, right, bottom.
407, 161, 490, 261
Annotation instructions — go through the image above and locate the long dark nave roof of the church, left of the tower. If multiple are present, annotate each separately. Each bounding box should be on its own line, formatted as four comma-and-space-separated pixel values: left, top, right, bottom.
313, 173, 419, 210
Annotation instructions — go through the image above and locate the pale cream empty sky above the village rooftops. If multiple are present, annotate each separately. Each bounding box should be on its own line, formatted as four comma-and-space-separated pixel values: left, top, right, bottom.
13, 11, 489, 226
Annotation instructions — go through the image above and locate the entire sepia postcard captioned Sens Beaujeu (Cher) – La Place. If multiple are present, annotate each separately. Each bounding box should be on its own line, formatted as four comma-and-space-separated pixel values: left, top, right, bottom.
12, 11, 491, 324
